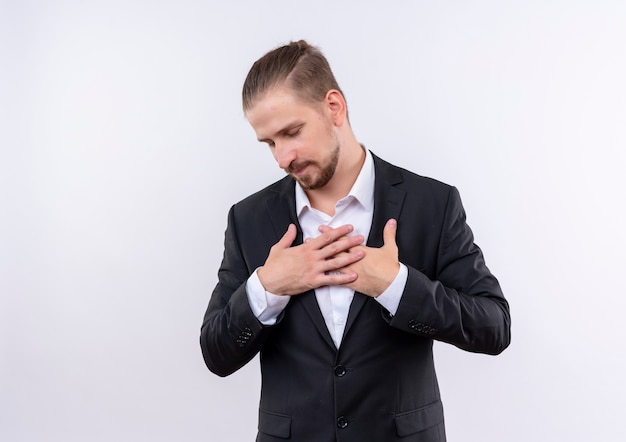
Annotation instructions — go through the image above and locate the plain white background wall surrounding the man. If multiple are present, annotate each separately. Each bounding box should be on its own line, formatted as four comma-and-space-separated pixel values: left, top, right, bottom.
0, 0, 626, 442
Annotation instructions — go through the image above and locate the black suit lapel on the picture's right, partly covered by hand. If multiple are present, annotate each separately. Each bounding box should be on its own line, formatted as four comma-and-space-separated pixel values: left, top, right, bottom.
343, 154, 406, 344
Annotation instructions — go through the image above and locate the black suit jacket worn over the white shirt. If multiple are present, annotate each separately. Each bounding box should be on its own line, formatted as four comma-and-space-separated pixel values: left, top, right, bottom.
200, 156, 510, 442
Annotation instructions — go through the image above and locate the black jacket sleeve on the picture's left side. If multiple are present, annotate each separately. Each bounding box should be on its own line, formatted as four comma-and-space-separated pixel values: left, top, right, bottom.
200, 207, 270, 376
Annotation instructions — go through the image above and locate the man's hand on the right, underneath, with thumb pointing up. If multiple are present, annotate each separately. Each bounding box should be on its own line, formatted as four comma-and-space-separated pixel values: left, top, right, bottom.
320, 219, 400, 298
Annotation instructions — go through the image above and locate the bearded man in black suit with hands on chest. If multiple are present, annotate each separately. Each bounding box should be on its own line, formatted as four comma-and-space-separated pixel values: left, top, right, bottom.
200, 41, 510, 442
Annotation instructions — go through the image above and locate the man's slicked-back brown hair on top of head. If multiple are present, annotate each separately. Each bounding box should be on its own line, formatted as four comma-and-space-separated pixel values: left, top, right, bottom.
241, 40, 343, 112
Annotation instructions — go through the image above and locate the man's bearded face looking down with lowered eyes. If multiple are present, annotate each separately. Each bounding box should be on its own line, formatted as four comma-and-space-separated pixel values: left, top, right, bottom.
246, 87, 340, 190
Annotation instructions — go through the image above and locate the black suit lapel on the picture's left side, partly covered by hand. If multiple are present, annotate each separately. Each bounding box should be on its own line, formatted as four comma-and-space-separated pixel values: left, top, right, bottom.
267, 177, 335, 348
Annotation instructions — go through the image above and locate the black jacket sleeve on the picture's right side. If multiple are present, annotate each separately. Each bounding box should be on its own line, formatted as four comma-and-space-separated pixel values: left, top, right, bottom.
390, 187, 511, 355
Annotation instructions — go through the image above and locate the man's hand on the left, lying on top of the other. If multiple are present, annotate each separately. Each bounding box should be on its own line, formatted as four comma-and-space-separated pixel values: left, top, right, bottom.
257, 224, 366, 295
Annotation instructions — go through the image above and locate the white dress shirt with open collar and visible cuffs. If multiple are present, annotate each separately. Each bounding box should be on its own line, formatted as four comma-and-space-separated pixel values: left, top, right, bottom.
246, 149, 408, 348
